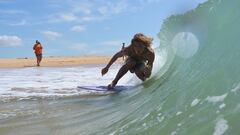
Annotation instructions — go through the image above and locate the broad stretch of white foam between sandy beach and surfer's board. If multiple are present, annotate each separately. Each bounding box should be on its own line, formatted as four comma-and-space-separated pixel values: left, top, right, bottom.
0, 65, 132, 100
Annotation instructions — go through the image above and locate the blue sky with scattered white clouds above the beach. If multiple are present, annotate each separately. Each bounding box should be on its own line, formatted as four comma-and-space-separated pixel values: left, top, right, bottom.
0, 0, 206, 58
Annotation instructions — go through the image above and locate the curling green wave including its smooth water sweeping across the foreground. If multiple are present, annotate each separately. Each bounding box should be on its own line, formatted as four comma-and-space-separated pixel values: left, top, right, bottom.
0, 0, 240, 135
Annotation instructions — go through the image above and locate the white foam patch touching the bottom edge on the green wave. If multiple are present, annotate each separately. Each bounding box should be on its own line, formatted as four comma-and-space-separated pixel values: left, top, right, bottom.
213, 118, 228, 135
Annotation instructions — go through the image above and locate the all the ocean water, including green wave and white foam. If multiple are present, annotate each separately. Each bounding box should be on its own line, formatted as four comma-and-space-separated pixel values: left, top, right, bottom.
0, 0, 240, 135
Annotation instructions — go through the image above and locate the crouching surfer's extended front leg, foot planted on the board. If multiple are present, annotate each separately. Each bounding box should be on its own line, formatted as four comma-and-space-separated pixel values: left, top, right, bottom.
108, 60, 136, 89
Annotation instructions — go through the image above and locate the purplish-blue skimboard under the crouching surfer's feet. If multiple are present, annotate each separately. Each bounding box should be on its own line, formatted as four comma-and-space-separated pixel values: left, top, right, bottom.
78, 85, 133, 91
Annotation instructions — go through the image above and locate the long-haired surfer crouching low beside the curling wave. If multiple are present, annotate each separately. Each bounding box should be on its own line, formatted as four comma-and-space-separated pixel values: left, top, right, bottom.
102, 33, 155, 89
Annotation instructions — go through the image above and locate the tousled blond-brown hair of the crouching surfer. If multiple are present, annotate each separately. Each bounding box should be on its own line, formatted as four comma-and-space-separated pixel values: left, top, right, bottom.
131, 33, 153, 47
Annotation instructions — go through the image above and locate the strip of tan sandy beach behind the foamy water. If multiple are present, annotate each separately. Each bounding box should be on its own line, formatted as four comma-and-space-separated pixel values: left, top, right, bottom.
0, 56, 119, 68
